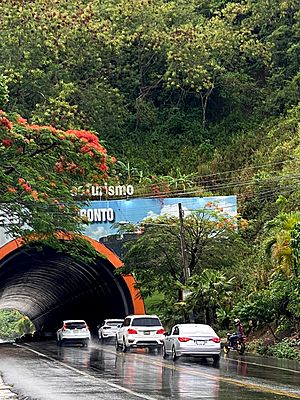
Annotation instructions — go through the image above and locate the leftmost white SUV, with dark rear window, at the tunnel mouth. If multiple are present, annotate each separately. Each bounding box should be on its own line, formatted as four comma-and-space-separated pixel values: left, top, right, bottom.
56, 319, 91, 346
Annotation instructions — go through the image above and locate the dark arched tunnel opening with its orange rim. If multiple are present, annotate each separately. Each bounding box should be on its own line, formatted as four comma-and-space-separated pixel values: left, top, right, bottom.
0, 237, 145, 331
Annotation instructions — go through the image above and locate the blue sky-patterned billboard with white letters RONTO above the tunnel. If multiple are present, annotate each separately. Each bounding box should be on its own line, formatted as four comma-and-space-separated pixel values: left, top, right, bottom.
80, 196, 237, 240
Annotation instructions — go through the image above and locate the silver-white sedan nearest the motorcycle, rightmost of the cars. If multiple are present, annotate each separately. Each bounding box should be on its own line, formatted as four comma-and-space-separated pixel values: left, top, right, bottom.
163, 324, 221, 362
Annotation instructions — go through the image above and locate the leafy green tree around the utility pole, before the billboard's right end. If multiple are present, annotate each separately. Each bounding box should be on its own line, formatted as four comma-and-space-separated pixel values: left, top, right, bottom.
122, 208, 246, 324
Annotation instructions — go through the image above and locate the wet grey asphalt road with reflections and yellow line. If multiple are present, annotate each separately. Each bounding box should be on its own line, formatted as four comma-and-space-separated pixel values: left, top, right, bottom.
0, 341, 300, 400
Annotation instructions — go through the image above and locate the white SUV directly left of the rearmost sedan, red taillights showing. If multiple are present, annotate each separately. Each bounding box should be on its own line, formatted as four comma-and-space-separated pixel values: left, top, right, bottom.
116, 315, 165, 353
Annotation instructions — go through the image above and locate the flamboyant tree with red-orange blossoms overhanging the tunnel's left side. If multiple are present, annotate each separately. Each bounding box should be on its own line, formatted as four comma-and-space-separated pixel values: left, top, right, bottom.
0, 107, 116, 256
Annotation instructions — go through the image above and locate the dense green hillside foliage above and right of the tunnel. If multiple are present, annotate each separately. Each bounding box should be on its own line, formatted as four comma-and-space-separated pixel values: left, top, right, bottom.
0, 0, 300, 354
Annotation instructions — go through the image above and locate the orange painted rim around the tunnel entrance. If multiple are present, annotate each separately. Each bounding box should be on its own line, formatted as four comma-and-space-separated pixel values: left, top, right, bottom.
0, 236, 145, 314
